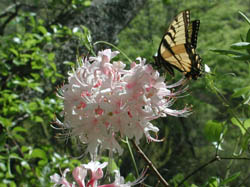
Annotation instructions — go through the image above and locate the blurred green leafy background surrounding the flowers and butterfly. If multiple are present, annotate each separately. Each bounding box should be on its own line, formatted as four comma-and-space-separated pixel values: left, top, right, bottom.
0, 0, 250, 186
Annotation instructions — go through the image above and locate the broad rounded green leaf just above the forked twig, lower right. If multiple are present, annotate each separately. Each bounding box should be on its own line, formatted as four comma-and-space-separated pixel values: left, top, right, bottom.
204, 120, 224, 142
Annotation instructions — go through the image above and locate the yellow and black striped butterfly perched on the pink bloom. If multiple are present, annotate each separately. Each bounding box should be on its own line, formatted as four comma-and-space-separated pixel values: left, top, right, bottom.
155, 10, 202, 79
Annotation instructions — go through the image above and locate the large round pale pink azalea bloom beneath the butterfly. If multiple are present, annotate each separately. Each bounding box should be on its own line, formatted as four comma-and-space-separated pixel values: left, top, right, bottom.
58, 49, 190, 154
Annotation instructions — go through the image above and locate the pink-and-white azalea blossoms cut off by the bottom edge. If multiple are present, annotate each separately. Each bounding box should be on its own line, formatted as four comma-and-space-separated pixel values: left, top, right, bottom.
50, 161, 144, 187
